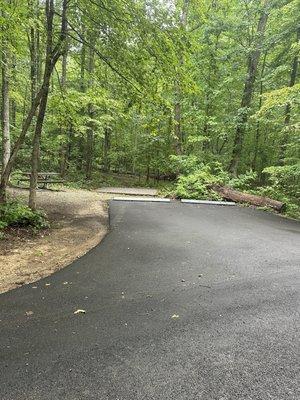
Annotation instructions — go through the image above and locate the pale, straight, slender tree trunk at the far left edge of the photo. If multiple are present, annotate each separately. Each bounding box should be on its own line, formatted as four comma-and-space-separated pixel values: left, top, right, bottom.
2, 36, 10, 171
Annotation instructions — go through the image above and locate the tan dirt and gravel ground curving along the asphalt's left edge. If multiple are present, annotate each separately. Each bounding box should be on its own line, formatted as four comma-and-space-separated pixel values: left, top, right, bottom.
0, 189, 110, 293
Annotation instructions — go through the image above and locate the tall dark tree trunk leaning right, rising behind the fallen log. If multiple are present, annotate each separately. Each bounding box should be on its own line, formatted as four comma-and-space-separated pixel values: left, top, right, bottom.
229, 1, 269, 175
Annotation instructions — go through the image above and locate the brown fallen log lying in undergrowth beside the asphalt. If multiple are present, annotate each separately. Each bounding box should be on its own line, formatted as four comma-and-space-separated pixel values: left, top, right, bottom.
211, 185, 285, 212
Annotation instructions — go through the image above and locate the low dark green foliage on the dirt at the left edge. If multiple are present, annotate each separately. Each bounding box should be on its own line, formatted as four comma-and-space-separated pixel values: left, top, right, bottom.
0, 201, 49, 229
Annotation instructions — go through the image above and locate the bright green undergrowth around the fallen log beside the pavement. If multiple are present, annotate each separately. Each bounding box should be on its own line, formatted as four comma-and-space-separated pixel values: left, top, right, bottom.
160, 162, 300, 219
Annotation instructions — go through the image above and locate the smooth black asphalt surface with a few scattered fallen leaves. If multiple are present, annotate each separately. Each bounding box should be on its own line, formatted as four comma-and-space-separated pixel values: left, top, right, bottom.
0, 202, 300, 400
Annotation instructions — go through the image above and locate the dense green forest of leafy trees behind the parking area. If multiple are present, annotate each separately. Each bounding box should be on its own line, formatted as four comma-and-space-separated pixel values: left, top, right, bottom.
0, 0, 300, 222
